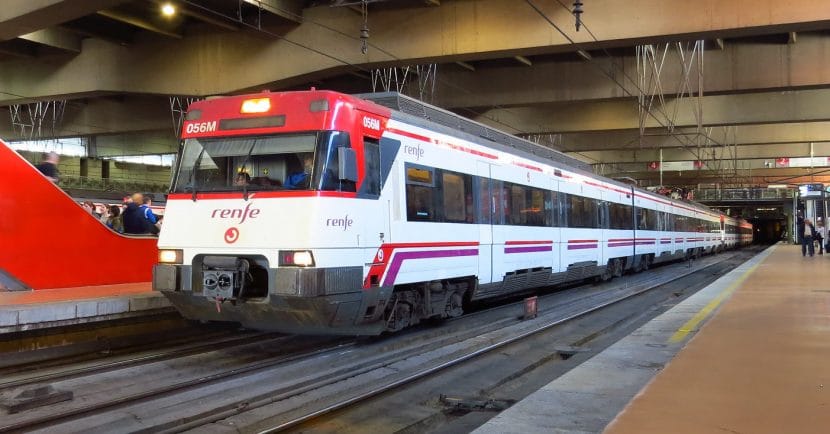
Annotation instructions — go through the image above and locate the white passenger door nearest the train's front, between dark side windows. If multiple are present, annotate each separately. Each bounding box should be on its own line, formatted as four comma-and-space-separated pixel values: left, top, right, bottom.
474, 161, 496, 284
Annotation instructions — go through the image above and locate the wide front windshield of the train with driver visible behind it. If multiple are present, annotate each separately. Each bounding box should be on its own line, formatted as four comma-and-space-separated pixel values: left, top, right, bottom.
173, 131, 355, 193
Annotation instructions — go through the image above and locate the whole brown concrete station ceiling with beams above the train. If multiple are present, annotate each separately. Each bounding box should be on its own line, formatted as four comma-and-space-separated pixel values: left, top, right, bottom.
0, 0, 830, 185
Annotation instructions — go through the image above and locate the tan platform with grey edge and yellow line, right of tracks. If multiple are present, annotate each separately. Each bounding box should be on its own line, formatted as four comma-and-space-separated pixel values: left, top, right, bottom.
474, 244, 830, 434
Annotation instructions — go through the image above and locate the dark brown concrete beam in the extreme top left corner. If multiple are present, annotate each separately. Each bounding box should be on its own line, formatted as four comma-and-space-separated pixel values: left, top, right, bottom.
0, 0, 127, 41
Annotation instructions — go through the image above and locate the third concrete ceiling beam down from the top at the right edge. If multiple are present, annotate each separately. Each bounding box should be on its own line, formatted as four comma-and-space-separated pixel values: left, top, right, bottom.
476, 89, 830, 133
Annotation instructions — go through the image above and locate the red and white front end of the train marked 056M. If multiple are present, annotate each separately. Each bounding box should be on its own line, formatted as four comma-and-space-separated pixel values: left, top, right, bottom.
153, 91, 391, 334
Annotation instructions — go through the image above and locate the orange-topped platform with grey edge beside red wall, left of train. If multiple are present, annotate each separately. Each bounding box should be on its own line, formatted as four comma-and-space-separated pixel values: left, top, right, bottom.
0, 282, 173, 334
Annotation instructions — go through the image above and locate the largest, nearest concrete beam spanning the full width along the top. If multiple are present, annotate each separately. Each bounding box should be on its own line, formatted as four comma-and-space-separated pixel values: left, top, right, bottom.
0, 0, 830, 104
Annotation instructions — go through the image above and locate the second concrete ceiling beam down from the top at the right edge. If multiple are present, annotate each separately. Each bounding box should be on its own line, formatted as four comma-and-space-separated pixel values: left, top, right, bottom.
435, 33, 830, 109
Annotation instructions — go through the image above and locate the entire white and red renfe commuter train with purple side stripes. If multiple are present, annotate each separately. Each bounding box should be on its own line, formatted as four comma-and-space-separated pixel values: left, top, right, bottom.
153, 90, 752, 335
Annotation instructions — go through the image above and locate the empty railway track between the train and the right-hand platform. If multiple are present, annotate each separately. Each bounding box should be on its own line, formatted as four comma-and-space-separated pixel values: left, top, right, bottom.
0, 248, 760, 432
